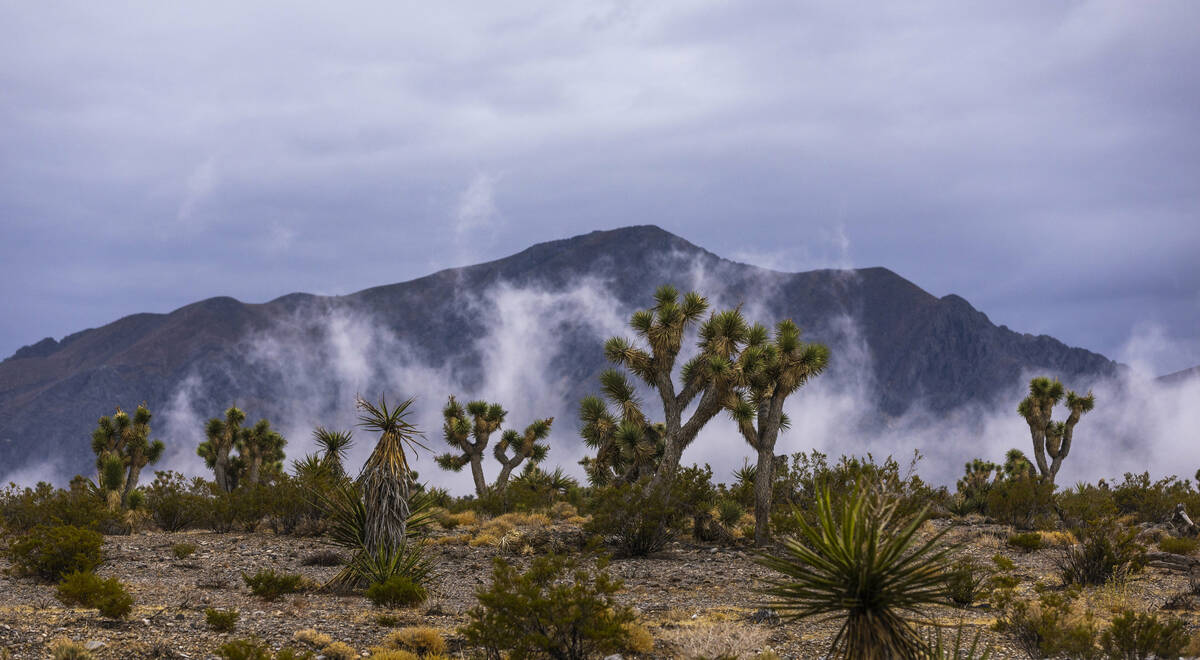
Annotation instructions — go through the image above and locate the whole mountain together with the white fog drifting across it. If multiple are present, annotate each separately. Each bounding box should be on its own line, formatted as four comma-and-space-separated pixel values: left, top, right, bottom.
0, 226, 1200, 492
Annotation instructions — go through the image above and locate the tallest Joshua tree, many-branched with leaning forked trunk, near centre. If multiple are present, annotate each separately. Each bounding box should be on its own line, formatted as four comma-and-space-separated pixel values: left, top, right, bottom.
604, 284, 749, 488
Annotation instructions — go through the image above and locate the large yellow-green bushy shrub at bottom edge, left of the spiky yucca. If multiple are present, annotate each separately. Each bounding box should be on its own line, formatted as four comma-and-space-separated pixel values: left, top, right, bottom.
458, 554, 635, 659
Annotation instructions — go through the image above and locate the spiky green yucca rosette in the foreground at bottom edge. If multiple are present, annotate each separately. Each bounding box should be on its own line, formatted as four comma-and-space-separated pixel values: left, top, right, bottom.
758, 485, 949, 660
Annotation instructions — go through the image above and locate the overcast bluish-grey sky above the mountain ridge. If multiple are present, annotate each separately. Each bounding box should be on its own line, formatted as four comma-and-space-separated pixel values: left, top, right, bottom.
0, 0, 1200, 373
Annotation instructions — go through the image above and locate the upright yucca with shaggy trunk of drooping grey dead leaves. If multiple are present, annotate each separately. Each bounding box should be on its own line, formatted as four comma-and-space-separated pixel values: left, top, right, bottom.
356, 397, 427, 556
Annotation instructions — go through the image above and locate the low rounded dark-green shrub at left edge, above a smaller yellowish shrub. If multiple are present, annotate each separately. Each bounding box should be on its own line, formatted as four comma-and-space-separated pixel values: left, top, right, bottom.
7, 524, 104, 582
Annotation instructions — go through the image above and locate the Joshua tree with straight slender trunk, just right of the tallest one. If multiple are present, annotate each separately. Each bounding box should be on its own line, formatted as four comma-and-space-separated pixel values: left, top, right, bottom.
726, 319, 829, 546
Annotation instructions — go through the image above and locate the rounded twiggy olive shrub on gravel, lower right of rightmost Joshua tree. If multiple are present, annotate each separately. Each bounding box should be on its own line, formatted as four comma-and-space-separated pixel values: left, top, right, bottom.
1055, 521, 1146, 586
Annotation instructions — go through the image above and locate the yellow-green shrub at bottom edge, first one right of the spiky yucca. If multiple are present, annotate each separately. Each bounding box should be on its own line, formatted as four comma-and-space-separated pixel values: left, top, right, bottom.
995, 592, 1096, 658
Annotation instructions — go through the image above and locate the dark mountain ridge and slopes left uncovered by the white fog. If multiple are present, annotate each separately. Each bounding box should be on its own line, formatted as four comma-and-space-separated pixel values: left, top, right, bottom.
0, 226, 1118, 482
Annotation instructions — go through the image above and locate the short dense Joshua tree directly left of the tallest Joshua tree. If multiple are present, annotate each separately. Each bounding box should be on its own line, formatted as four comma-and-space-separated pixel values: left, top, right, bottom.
580, 370, 666, 486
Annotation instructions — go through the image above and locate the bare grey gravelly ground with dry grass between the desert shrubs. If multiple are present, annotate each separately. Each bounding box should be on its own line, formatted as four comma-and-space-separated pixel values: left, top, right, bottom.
0, 521, 1200, 659
